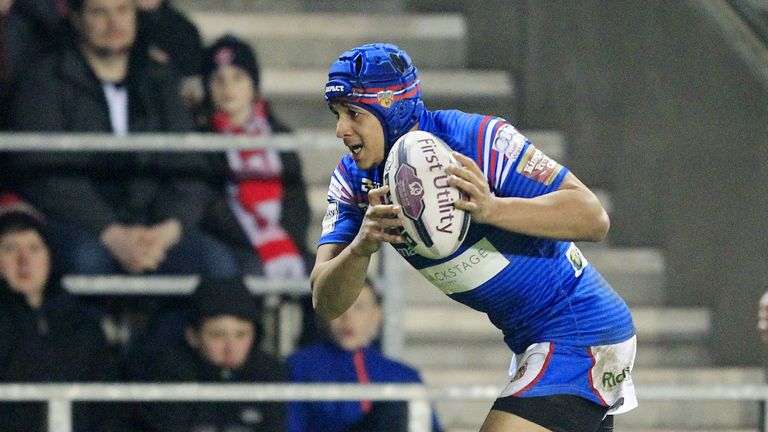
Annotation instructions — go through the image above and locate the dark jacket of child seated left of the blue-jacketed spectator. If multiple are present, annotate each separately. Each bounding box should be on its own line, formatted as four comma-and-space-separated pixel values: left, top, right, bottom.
136, 345, 287, 432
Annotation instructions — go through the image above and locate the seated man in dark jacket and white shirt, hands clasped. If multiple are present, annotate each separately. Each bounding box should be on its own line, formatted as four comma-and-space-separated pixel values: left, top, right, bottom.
6, 0, 238, 277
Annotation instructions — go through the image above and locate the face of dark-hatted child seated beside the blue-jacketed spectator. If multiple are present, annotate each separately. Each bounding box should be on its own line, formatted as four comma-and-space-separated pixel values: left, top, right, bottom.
188, 315, 255, 369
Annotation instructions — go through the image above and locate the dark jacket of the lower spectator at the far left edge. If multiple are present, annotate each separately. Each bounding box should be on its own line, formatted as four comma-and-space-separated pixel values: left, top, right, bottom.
0, 279, 118, 432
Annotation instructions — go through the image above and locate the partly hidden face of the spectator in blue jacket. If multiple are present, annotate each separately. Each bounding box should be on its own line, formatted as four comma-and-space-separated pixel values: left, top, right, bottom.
329, 287, 382, 351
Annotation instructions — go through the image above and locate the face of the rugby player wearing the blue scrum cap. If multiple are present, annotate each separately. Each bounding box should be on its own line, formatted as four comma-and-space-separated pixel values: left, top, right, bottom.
331, 103, 384, 169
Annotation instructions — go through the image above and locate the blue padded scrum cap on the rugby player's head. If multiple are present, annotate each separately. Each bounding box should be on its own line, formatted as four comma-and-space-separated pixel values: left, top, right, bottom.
325, 43, 424, 148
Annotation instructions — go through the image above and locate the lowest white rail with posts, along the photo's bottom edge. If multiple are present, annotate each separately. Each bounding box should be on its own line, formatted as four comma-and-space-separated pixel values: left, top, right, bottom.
0, 384, 768, 432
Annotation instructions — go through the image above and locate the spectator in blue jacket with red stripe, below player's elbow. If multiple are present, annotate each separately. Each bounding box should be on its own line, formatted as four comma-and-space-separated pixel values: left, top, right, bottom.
287, 280, 440, 432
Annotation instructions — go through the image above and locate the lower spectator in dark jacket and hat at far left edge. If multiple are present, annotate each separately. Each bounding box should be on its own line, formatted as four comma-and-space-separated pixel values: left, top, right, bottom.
0, 210, 121, 432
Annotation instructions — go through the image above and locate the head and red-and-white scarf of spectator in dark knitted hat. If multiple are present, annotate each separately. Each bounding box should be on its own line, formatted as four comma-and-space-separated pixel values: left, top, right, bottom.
202, 36, 309, 277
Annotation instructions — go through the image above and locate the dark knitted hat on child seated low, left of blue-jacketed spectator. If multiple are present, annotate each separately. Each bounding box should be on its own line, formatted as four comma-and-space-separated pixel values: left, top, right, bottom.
191, 279, 259, 328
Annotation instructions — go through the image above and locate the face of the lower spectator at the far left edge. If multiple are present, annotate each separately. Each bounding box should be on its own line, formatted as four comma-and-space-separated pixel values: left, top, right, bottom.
0, 230, 51, 297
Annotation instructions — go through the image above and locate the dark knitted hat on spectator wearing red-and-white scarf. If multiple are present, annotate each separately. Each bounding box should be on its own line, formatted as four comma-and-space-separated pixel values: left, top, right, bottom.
202, 35, 259, 90
